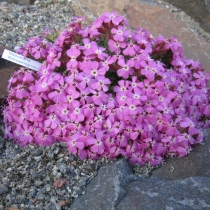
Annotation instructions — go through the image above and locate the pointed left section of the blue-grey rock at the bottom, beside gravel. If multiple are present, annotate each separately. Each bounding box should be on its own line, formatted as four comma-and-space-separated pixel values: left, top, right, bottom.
71, 159, 137, 210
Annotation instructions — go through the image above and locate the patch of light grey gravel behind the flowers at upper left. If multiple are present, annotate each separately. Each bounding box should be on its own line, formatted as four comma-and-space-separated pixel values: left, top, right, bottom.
0, 0, 74, 49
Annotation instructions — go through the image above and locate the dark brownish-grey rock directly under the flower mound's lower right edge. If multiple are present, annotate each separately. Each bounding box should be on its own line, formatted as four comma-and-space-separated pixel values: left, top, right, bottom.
153, 130, 210, 180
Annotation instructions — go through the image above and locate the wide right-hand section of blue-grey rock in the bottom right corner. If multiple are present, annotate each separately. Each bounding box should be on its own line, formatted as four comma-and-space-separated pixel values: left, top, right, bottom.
115, 177, 210, 210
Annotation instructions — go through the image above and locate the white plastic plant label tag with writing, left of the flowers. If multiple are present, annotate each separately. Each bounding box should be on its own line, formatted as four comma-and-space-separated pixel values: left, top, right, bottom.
2, 49, 42, 71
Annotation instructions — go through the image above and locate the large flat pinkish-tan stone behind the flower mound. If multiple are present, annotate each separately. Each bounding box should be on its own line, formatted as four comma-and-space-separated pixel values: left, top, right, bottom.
73, 0, 210, 72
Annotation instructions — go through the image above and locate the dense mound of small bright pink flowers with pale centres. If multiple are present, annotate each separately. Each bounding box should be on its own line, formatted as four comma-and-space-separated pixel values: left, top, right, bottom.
4, 12, 210, 166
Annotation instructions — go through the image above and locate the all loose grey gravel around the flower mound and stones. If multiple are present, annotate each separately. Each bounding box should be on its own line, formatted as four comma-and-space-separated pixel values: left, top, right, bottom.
0, 0, 209, 210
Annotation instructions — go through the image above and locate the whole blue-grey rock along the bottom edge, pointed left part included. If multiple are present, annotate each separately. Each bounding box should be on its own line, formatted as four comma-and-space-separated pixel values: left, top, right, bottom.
71, 159, 210, 210
